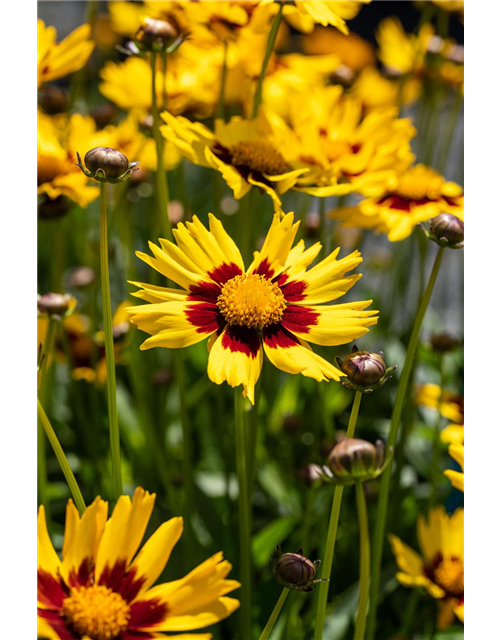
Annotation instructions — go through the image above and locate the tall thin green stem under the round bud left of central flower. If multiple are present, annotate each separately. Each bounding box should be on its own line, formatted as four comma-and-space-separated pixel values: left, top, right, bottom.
99, 182, 123, 500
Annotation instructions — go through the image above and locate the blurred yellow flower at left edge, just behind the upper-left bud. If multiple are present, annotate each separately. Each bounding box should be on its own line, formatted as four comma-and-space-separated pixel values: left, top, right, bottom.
36, 111, 103, 207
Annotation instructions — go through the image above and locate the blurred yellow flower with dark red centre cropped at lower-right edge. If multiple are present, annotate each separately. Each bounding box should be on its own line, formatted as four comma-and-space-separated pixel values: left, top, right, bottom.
389, 506, 464, 629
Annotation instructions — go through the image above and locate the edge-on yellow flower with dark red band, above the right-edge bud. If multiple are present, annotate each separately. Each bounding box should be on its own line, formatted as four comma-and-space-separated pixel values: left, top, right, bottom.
331, 164, 464, 242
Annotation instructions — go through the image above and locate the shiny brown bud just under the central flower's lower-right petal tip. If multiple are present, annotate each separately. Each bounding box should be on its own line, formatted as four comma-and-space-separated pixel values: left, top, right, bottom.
336, 345, 397, 393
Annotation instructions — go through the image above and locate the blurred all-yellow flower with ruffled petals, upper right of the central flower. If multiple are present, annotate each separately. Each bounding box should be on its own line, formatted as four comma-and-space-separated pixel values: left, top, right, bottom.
289, 86, 415, 197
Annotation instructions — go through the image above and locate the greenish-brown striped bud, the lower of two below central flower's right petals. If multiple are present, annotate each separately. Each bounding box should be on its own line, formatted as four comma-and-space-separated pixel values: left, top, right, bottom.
323, 438, 392, 484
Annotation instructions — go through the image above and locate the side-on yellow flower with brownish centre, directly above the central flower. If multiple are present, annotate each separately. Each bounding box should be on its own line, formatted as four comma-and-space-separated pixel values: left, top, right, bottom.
161, 110, 307, 210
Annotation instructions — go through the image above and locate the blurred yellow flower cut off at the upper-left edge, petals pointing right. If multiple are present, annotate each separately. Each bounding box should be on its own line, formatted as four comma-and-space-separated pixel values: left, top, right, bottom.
36, 20, 94, 88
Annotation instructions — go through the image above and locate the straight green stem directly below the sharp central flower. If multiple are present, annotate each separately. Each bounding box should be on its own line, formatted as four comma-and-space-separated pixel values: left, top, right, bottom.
234, 388, 252, 639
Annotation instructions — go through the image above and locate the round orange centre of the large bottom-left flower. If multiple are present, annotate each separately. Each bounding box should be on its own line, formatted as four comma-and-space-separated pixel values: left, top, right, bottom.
61, 585, 130, 640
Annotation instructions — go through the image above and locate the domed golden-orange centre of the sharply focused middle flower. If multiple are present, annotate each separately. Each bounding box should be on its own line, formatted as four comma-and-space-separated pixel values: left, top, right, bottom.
217, 274, 286, 329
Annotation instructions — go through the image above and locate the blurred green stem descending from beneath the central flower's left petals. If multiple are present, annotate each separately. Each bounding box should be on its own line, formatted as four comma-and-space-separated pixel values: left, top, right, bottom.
174, 351, 195, 563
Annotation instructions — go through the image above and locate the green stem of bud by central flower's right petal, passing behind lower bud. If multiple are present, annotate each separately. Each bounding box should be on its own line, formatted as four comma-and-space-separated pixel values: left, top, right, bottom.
314, 391, 362, 640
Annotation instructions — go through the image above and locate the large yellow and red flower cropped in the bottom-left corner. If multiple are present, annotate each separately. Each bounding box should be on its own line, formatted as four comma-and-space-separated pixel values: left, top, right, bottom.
37, 488, 240, 640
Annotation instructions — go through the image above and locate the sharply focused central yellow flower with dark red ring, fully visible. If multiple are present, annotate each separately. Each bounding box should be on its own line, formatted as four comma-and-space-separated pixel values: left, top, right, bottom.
128, 213, 377, 403
